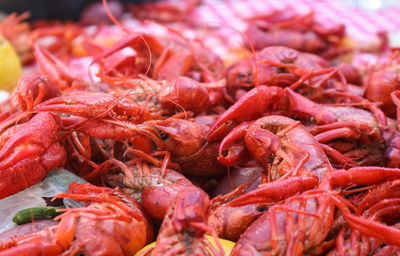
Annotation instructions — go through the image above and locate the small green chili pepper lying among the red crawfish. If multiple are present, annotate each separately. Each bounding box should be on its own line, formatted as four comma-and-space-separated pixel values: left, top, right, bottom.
12, 206, 65, 225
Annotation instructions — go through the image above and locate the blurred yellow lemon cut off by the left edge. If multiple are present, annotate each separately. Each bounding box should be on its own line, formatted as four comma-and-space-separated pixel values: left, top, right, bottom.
0, 36, 22, 91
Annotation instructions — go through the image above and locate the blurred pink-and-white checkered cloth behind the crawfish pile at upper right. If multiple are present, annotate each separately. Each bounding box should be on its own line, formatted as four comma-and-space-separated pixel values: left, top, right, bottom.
189, 0, 400, 53
